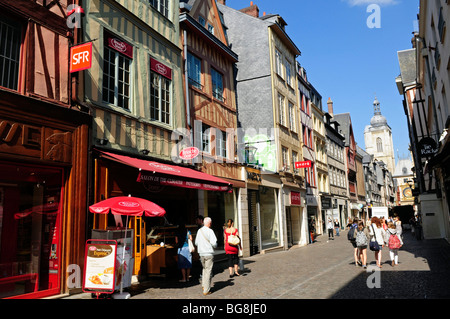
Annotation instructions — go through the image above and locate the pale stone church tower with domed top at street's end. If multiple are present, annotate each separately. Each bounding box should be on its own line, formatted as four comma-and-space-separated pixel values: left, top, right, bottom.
364, 98, 395, 174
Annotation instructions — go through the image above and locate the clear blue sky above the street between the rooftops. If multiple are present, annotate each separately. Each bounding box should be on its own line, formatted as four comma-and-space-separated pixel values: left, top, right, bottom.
227, 0, 419, 162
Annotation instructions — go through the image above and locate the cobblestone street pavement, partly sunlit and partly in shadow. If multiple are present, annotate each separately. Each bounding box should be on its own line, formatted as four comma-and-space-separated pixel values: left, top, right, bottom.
63, 232, 450, 302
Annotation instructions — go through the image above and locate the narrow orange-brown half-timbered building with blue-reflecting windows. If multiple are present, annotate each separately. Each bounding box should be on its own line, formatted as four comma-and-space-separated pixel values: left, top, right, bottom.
180, 0, 244, 252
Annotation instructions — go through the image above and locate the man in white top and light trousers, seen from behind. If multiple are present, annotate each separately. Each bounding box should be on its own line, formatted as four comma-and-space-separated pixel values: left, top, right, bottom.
195, 217, 217, 296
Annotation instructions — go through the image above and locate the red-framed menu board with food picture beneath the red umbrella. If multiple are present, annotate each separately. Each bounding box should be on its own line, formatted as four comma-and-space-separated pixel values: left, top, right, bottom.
83, 240, 117, 293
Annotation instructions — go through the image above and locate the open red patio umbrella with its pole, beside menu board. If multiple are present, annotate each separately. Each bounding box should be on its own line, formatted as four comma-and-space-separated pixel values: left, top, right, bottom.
89, 195, 166, 299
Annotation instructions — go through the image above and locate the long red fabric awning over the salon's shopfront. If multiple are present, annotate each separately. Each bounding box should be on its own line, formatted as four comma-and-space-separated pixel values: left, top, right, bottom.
100, 152, 232, 192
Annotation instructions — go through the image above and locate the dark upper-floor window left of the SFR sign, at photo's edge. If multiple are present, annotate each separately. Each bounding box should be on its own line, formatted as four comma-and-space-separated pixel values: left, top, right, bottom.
0, 16, 21, 90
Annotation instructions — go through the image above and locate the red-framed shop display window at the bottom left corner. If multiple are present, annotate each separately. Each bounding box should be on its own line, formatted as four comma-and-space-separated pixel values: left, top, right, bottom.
0, 162, 63, 298
